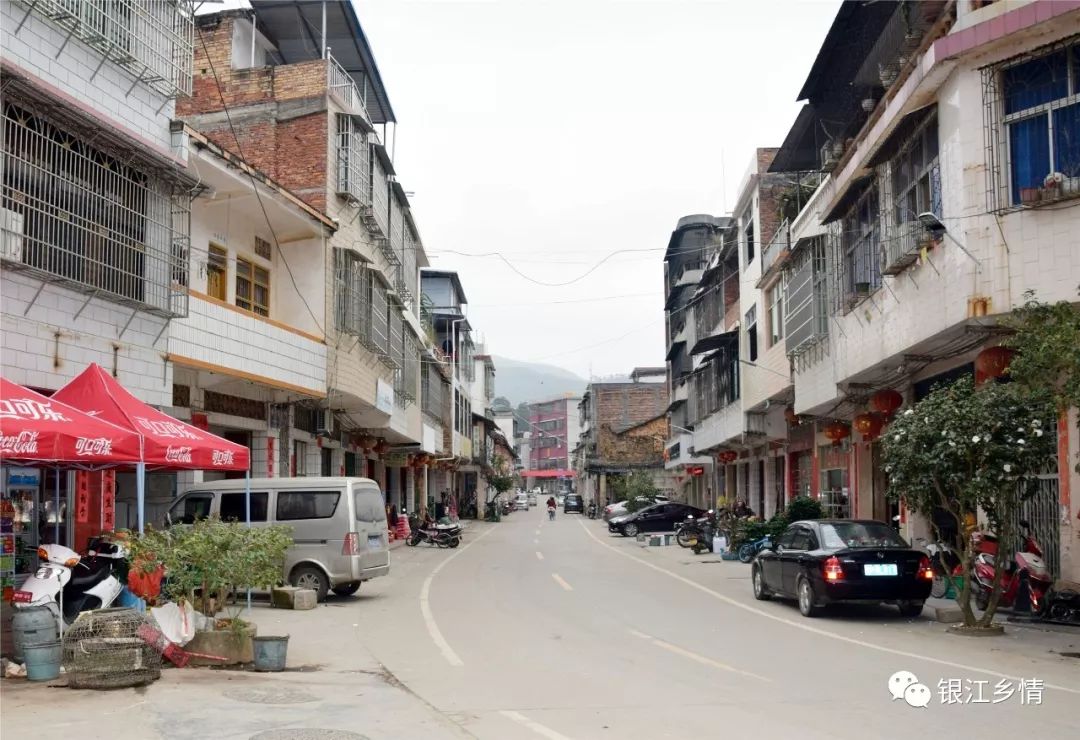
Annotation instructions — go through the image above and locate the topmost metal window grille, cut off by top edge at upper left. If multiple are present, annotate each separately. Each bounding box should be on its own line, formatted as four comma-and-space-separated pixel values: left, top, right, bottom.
15, 0, 194, 97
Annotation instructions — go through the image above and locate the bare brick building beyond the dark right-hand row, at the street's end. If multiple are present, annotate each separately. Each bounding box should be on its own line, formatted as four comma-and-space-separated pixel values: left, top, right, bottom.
573, 367, 675, 507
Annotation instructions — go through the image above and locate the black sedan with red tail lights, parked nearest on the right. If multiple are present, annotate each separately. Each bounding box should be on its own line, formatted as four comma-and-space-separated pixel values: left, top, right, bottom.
751, 520, 934, 617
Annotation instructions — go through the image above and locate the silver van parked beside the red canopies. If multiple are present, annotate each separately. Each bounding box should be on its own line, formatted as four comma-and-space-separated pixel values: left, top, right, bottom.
166, 477, 390, 602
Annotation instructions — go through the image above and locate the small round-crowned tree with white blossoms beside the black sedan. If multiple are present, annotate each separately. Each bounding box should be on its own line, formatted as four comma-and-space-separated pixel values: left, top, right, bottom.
882, 378, 1056, 629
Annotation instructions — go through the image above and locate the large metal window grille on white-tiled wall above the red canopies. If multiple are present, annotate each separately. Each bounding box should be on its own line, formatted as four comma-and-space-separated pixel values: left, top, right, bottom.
0, 104, 190, 318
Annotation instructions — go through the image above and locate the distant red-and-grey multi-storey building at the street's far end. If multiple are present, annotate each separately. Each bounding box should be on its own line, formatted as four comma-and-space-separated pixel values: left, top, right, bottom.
522, 394, 581, 493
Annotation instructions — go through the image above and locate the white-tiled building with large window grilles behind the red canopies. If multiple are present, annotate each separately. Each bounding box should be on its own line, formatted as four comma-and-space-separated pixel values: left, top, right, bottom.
0, 0, 198, 531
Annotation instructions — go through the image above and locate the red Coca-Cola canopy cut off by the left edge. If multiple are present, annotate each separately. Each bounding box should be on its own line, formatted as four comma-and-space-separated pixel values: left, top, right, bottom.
0, 378, 139, 468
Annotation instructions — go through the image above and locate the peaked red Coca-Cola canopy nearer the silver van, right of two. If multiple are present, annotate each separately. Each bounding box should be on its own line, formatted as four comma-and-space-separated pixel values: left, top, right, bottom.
53, 364, 251, 470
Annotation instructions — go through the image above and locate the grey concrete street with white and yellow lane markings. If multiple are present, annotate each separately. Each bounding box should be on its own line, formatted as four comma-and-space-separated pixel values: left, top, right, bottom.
2, 509, 1080, 740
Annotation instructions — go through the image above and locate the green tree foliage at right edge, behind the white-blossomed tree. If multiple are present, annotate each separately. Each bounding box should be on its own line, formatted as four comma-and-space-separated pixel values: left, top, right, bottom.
1001, 291, 1080, 471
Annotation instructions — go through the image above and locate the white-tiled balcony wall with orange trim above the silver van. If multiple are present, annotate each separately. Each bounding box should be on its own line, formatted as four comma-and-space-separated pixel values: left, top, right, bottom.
168, 296, 326, 393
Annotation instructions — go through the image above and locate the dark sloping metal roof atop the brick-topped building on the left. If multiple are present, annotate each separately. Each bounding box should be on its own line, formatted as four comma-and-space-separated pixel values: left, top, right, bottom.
251, 0, 397, 123
